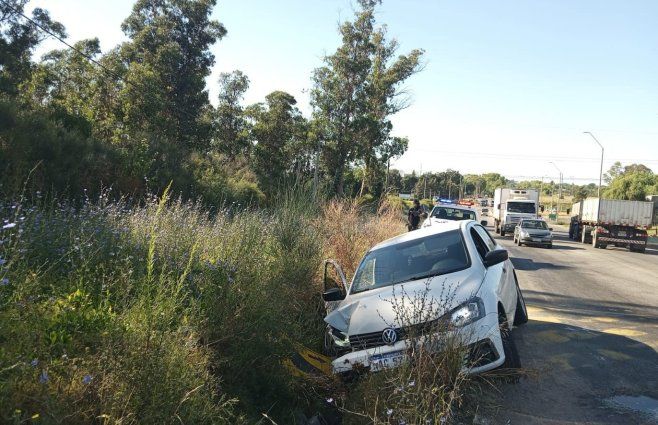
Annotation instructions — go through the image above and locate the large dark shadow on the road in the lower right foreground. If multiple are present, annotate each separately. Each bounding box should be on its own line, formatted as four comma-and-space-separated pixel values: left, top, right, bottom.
485, 320, 658, 424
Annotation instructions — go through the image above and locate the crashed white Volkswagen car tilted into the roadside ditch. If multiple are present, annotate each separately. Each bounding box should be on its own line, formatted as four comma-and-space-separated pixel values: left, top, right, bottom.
323, 221, 528, 374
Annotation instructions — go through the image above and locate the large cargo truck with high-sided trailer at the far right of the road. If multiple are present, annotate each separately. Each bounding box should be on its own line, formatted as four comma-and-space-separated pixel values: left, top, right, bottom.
569, 198, 654, 252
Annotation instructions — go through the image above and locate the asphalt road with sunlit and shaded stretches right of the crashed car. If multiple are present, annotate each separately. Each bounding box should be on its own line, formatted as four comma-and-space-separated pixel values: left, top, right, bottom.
487, 224, 658, 424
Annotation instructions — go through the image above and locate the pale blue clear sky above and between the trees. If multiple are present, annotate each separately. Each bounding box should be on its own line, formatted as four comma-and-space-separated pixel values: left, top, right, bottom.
31, 0, 658, 183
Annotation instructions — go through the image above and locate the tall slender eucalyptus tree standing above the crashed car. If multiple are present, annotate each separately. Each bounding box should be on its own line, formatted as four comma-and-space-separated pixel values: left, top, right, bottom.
311, 0, 423, 195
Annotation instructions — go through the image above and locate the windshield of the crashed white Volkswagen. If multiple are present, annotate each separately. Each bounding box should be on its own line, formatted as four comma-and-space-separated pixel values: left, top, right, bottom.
351, 230, 470, 293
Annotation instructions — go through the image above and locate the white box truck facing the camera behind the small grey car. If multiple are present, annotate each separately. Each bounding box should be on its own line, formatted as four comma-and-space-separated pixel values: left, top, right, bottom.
493, 188, 539, 236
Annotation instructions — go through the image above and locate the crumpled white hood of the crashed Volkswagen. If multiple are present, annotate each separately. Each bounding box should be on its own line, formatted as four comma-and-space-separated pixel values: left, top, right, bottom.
324, 267, 484, 335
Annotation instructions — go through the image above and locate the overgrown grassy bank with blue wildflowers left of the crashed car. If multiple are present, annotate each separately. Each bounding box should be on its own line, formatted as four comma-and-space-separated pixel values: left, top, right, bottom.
0, 190, 472, 424
